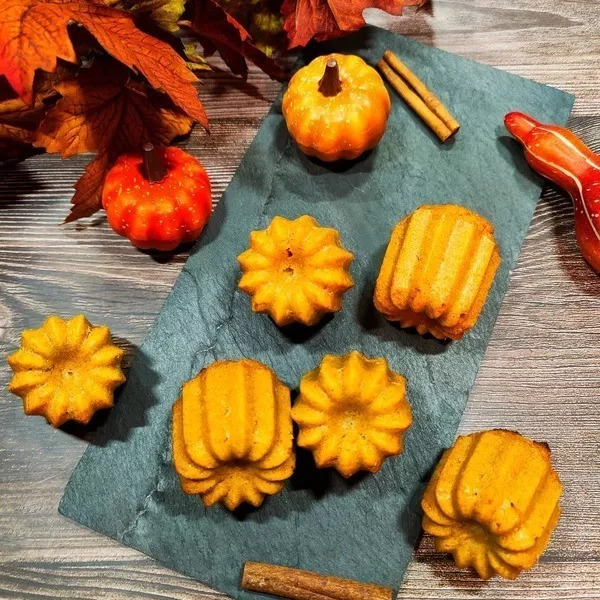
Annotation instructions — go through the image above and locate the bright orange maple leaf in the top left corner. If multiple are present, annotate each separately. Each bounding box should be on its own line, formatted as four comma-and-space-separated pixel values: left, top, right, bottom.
0, 0, 208, 128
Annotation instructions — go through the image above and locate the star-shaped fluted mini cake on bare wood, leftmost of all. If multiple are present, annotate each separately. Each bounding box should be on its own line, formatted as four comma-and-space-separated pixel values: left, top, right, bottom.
8, 315, 125, 427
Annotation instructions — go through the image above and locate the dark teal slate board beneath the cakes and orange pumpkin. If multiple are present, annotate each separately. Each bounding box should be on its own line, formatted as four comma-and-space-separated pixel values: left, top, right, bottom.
59, 28, 573, 599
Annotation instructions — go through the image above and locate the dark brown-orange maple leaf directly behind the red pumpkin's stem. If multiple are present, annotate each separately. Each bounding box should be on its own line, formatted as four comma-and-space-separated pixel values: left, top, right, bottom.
35, 61, 194, 222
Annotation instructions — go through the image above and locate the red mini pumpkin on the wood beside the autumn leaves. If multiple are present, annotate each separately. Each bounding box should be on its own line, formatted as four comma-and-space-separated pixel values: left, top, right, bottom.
102, 144, 212, 250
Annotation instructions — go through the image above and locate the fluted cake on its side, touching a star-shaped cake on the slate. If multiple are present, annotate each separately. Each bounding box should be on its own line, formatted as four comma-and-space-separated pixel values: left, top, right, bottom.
172, 359, 296, 510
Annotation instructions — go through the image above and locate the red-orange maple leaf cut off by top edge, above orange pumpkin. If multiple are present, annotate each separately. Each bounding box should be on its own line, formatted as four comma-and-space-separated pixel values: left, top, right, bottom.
281, 0, 427, 48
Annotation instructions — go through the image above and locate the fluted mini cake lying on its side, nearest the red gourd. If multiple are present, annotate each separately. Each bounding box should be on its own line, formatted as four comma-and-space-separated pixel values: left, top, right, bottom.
373, 204, 500, 340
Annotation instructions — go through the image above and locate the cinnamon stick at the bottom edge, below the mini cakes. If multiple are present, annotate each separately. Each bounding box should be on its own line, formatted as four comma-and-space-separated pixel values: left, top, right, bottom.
242, 561, 393, 600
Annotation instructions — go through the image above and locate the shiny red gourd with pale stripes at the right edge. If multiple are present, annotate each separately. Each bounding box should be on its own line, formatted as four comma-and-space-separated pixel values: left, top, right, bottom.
504, 112, 600, 273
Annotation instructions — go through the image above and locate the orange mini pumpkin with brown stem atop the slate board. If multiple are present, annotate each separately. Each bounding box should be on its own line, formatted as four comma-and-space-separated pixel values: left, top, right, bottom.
282, 54, 391, 161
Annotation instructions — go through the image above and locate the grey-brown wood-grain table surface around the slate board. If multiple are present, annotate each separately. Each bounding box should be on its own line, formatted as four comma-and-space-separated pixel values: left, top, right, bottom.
0, 0, 600, 600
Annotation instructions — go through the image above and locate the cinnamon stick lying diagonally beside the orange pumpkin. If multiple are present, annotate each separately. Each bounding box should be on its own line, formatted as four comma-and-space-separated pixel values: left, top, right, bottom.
377, 50, 460, 142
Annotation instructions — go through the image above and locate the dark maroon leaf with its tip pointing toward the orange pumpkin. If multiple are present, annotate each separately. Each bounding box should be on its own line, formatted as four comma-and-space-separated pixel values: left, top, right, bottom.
181, 0, 287, 81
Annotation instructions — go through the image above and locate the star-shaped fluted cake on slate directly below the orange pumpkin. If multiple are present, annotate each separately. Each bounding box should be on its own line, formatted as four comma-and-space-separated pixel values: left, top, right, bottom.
238, 215, 354, 327
